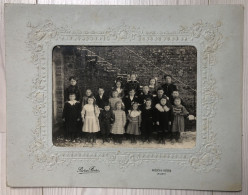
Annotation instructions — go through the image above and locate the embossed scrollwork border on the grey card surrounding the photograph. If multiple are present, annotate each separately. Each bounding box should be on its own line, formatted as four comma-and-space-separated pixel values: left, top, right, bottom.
26, 20, 223, 172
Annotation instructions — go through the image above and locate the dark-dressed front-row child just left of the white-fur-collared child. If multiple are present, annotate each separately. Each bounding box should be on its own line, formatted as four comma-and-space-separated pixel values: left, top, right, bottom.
141, 98, 154, 142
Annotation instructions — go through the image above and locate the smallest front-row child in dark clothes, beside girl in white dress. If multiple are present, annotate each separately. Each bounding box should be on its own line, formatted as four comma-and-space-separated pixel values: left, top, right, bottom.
99, 103, 115, 143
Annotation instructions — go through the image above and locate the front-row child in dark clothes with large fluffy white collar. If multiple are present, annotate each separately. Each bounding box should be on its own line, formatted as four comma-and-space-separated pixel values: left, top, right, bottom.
155, 96, 171, 144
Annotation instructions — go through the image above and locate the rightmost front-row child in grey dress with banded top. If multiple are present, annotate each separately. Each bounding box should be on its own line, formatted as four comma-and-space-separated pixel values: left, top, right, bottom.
172, 98, 189, 143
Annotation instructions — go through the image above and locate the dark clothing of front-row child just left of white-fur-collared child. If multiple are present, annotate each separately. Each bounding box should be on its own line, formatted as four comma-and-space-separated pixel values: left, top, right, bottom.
141, 106, 154, 140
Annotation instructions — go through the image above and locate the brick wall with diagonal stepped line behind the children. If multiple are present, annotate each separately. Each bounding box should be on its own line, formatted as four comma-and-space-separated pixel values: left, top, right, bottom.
53, 46, 197, 129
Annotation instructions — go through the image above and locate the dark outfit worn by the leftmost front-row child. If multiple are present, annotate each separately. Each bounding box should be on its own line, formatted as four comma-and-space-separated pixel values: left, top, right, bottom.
62, 101, 81, 137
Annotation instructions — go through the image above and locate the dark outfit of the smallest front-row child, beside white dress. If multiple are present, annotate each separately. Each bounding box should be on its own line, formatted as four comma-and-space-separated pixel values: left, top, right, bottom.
99, 110, 115, 135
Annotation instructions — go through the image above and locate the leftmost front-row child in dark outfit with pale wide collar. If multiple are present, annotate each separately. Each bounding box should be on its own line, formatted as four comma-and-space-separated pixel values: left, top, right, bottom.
62, 93, 81, 142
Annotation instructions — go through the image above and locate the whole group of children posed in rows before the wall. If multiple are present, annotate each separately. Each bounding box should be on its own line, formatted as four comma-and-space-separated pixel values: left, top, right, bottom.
63, 74, 189, 144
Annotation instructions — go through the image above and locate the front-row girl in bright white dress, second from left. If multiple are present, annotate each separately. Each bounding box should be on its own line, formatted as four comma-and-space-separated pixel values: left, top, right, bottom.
81, 96, 100, 144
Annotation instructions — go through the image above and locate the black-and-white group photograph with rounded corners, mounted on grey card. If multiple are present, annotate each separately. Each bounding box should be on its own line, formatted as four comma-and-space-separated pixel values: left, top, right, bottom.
52, 45, 197, 148
